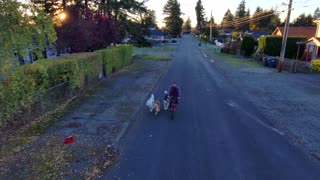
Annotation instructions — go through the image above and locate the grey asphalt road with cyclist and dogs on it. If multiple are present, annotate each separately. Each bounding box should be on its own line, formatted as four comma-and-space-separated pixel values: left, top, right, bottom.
101, 37, 320, 180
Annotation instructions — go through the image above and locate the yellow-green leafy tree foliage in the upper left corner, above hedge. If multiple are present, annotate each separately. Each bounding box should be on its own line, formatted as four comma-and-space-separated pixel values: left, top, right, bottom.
0, 0, 56, 73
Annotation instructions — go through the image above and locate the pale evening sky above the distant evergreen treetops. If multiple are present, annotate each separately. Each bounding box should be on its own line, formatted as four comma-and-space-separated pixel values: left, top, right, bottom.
145, 0, 320, 27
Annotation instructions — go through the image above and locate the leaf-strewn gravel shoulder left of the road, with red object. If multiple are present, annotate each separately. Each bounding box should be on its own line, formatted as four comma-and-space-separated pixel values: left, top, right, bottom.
0, 47, 173, 179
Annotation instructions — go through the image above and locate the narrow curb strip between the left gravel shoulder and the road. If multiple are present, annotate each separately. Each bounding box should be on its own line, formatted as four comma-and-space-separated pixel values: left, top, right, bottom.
112, 60, 172, 147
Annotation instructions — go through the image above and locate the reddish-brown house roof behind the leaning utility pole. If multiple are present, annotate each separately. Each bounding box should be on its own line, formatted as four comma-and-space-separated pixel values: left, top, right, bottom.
272, 26, 317, 39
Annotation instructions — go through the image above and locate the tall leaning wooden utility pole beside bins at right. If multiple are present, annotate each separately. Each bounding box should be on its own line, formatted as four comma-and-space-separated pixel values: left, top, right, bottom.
278, 0, 292, 72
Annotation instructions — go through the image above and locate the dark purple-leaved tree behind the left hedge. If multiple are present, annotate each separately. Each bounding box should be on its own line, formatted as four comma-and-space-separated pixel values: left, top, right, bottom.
56, 6, 119, 52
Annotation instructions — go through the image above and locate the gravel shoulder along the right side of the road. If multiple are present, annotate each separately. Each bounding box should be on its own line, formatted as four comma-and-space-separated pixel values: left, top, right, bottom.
204, 44, 320, 158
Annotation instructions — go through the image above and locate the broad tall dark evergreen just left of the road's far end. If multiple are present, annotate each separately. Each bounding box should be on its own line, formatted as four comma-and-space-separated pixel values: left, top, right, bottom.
163, 0, 183, 37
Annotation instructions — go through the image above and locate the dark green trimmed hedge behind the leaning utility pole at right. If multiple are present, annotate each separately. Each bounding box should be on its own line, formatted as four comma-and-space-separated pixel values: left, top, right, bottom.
258, 36, 307, 58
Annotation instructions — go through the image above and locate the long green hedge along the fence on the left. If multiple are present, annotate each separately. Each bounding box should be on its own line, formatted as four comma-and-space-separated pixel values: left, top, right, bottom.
0, 46, 133, 127
